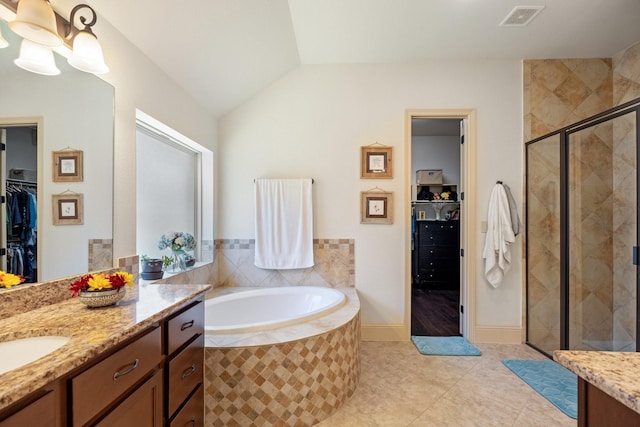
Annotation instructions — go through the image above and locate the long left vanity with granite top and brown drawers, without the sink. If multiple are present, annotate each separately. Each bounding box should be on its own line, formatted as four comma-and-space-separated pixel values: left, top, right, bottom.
0, 284, 211, 427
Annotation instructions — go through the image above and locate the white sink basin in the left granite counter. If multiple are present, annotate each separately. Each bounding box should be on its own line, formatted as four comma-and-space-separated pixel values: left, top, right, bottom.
0, 336, 69, 374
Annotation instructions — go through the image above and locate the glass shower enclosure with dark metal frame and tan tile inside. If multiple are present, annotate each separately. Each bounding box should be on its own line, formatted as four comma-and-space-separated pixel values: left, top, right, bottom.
526, 98, 640, 355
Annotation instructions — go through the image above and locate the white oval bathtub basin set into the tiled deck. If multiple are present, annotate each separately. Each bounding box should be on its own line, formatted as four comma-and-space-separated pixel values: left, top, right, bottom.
204, 286, 345, 334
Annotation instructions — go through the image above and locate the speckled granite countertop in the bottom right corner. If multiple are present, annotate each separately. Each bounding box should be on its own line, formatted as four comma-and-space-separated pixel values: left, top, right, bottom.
553, 350, 640, 413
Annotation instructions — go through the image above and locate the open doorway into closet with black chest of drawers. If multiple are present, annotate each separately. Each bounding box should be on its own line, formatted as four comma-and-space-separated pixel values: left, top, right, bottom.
410, 117, 463, 336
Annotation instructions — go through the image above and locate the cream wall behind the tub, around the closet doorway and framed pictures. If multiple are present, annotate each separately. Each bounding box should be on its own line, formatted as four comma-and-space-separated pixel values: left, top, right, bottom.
218, 61, 523, 338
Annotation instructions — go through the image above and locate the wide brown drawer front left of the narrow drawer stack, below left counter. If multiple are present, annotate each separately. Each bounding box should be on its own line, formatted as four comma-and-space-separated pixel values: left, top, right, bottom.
71, 328, 162, 425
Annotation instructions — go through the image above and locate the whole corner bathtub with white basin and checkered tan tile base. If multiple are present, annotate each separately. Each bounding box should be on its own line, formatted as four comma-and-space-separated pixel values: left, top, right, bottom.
204, 286, 360, 426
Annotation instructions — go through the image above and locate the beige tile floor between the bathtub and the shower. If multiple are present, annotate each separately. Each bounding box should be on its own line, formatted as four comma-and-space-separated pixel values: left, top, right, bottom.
318, 341, 577, 427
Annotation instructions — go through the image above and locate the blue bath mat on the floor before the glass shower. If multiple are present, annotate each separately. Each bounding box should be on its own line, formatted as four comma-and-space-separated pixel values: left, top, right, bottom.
502, 359, 578, 419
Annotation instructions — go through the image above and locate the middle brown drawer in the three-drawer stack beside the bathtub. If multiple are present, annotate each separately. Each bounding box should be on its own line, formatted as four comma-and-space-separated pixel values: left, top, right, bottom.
167, 335, 204, 415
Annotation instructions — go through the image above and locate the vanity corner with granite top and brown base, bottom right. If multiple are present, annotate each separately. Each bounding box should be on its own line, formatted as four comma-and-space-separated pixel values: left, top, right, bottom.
553, 350, 640, 427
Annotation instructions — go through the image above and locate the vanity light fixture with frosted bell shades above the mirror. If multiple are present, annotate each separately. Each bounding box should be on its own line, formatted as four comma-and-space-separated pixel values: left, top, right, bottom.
0, 0, 109, 75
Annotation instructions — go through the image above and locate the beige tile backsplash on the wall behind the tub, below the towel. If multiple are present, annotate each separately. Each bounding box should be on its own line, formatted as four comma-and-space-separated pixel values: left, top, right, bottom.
214, 239, 355, 288
